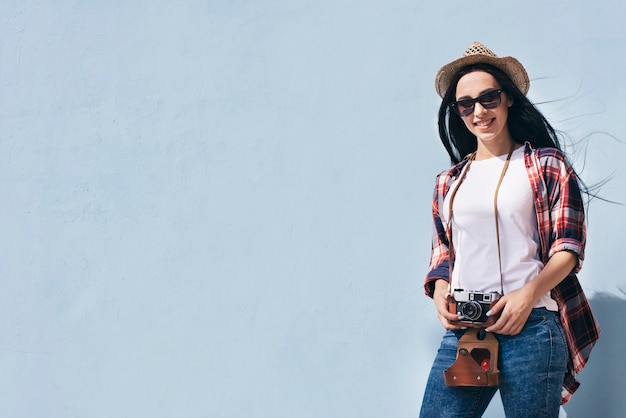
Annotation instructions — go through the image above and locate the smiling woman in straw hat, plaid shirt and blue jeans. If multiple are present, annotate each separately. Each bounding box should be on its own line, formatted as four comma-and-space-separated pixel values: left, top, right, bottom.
420, 43, 600, 417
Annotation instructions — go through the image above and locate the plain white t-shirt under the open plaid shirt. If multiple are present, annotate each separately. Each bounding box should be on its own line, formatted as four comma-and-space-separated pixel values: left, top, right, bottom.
442, 147, 557, 311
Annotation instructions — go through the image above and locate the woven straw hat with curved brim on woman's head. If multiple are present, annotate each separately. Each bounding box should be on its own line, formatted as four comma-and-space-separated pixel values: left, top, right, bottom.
435, 42, 530, 98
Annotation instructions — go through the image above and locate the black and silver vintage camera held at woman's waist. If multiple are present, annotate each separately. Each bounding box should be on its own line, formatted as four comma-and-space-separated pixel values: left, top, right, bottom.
448, 289, 501, 327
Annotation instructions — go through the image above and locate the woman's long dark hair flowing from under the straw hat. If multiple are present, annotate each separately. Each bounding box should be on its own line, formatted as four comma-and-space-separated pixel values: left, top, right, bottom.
439, 64, 562, 164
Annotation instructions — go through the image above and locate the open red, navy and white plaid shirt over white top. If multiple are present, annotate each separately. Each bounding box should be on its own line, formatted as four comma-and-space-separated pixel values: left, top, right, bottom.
424, 142, 600, 404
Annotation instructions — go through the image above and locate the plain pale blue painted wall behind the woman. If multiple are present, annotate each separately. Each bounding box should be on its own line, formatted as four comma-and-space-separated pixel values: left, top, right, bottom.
0, 0, 626, 418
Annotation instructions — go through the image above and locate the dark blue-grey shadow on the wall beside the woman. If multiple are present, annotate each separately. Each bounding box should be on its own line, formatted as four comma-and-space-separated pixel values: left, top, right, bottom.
565, 293, 626, 418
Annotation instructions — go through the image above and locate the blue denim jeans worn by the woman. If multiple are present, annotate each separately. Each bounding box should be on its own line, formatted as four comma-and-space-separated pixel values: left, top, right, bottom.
420, 309, 568, 418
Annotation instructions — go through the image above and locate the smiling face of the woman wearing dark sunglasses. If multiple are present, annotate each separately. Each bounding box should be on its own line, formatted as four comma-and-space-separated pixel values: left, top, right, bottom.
456, 71, 513, 146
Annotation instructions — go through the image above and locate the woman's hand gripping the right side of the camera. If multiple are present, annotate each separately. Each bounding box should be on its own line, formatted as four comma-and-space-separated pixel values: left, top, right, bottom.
487, 286, 535, 335
